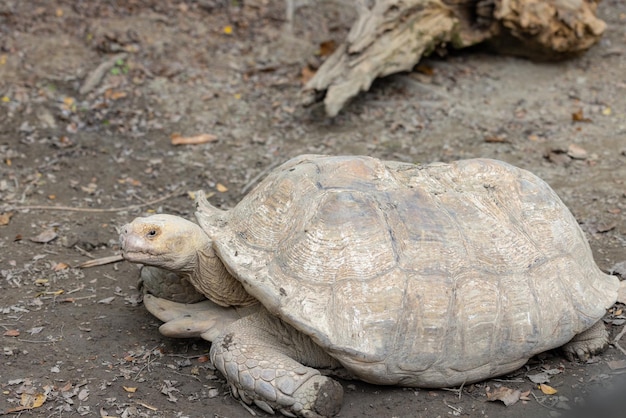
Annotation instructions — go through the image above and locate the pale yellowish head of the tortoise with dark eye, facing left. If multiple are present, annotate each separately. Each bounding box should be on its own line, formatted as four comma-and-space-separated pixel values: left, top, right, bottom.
120, 214, 211, 272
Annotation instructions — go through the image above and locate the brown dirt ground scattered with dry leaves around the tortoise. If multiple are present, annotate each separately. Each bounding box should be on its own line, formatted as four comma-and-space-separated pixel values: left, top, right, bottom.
0, 0, 626, 417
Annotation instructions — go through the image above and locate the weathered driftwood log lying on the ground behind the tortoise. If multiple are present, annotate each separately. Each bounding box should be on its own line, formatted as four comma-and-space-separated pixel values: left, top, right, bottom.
303, 0, 606, 116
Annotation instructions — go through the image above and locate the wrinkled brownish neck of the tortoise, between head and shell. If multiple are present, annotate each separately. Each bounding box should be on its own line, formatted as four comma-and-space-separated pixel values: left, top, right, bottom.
189, 245, 258, 306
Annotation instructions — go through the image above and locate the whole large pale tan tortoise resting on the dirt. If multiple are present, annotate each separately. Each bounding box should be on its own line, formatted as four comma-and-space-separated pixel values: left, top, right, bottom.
120, 155, 620, 417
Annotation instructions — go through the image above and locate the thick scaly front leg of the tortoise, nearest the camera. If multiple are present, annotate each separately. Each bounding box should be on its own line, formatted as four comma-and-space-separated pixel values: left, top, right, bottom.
210, 311, 343, 417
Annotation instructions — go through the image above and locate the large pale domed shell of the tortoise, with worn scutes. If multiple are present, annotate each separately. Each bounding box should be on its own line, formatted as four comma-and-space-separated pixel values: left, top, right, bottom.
196, 155, 618, 387
